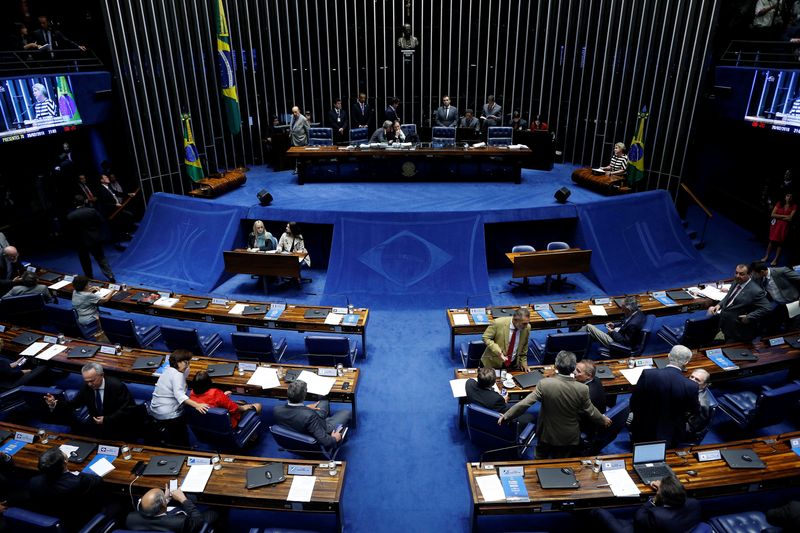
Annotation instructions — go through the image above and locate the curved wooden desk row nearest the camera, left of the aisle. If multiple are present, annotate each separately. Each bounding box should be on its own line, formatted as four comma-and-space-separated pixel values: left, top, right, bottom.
0, 422, 347, 530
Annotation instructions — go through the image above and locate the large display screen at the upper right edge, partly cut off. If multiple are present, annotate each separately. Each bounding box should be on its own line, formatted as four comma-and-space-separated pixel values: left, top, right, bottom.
744, 69, 800, 135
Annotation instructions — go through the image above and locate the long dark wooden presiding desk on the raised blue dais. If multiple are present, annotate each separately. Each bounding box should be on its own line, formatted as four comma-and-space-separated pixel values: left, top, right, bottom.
286, 146, 532, 185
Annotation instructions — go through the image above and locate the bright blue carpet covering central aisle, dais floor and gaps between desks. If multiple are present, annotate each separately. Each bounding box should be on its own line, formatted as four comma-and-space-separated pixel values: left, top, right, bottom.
26, 167, 794, 532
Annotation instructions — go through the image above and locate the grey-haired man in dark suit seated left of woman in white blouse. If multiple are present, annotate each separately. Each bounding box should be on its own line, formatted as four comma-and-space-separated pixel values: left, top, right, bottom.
44, 362, 135, 439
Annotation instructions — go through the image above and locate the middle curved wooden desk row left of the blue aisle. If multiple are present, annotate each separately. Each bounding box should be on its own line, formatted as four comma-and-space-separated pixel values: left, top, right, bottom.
0, 322, 361, 425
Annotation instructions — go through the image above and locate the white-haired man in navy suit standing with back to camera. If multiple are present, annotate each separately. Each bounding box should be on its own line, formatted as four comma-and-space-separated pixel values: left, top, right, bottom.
631, 344, 698, 448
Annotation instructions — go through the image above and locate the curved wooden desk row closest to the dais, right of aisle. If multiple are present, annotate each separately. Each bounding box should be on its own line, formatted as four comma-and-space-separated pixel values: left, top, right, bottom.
447, 280, 716, 357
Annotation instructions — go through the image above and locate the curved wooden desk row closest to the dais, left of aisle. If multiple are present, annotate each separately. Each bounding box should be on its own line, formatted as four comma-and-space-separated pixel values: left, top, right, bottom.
31, 268, 369, 358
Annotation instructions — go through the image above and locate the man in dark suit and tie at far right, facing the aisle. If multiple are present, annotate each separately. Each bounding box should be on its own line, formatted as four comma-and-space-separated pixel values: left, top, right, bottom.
708, 264, 770, 342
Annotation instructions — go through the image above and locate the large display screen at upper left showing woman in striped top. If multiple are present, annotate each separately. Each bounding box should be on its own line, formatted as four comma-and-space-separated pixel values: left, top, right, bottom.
0, 75, 82, 143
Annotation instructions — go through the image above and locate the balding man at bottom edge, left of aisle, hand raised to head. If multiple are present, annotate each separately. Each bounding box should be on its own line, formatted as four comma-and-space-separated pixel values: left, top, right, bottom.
125, 489, 218, 533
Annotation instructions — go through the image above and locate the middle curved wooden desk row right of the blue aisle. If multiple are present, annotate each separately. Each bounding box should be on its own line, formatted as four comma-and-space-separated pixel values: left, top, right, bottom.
455, 332, 800, 423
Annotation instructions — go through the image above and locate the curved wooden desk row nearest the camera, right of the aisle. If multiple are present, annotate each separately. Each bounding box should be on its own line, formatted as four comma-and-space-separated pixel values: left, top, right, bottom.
466, 432, 800, 529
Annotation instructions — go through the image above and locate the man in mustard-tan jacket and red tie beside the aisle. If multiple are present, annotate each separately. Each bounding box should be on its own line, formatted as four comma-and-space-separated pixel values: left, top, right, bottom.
481, 307, 531, 372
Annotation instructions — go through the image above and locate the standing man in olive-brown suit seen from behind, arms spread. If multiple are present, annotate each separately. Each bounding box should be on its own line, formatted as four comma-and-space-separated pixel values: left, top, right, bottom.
497, 351, 611, 459
